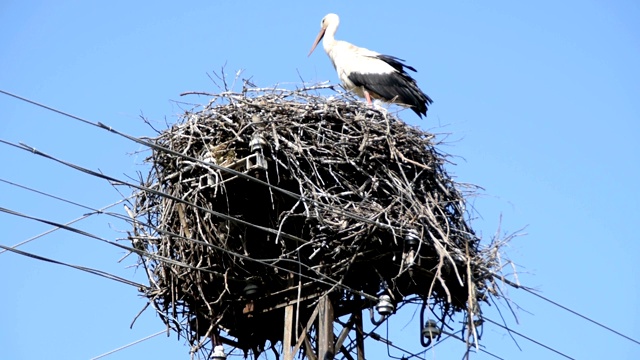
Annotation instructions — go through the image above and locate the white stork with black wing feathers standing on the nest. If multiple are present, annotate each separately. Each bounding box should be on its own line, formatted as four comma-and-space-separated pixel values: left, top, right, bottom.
308, 14, 433, 117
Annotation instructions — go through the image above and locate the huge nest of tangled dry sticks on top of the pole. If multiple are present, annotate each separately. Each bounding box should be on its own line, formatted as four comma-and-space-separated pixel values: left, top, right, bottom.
131, 88, 504, 358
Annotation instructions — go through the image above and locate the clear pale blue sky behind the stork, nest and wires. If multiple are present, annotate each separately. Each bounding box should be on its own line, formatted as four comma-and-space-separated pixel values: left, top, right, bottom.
0, 0, 640, 360
